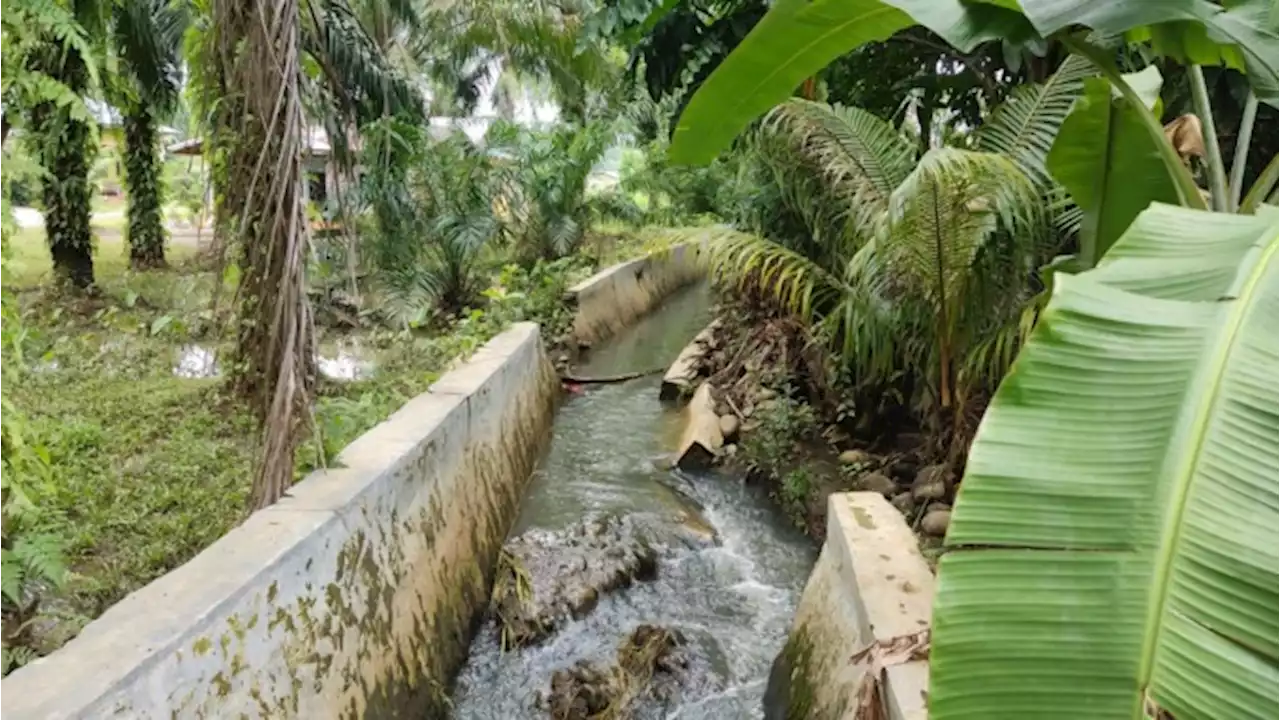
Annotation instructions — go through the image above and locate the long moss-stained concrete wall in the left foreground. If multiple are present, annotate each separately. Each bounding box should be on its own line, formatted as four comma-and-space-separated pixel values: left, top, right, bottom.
0, 324, 558, 720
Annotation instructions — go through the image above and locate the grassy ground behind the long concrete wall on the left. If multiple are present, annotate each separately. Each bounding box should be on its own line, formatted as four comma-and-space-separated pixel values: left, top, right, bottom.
0, 228, 644, 652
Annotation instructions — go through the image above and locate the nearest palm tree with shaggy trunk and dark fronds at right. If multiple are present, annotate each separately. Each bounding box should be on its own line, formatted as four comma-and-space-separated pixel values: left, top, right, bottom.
204, 0, 424, 507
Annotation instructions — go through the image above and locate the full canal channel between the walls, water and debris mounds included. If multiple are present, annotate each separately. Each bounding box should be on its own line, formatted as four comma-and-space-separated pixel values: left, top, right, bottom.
452, 286, 814, 720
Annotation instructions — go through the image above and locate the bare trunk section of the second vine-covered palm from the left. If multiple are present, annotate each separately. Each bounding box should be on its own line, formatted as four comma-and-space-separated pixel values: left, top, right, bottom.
124, 105, 165, 270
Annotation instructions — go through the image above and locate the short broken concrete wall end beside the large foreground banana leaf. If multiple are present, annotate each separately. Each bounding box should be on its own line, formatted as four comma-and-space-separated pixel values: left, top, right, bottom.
765, 492, 933, 720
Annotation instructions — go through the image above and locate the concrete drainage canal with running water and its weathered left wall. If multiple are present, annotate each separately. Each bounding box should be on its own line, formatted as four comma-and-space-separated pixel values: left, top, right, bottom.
0, 246, 849, 720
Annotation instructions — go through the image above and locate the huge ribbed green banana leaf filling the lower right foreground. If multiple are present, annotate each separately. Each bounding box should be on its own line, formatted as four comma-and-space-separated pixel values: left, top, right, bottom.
929, 205, 1280, 720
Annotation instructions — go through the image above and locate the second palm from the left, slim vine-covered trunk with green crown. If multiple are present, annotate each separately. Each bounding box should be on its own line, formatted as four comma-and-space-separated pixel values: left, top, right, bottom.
111, 0, 191, 269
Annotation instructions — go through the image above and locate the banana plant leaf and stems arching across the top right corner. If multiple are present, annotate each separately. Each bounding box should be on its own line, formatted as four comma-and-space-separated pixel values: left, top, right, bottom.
671, 0, 1280, 208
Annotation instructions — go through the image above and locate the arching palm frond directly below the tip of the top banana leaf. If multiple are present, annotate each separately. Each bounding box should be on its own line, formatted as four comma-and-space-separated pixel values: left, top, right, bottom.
762, 100, 915, 237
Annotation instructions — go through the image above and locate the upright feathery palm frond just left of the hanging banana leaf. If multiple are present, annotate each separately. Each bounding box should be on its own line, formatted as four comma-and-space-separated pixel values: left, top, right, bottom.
977, 55, 1097, 188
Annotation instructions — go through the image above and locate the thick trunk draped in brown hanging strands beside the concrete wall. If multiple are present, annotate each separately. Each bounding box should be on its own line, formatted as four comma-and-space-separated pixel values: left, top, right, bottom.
214, 0, 315, 507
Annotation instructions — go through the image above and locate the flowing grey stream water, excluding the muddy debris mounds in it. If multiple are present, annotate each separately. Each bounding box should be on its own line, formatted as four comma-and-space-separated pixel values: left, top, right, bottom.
453, 287, 814, 720
